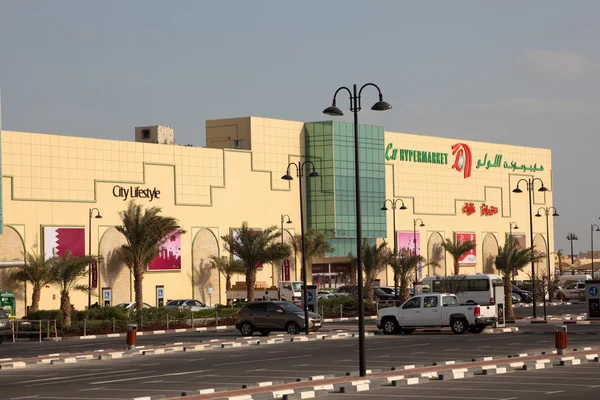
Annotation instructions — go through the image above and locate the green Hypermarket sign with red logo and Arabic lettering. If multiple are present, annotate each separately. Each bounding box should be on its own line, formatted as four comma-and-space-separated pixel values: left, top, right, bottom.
385, 143, 544, 179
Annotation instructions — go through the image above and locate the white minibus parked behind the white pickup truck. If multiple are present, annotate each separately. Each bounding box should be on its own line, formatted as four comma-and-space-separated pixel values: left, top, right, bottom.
423, 274, 502, 305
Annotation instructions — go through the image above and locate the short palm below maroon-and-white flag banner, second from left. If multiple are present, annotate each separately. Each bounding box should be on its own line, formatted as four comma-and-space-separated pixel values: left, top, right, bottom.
48, 250, 98, 326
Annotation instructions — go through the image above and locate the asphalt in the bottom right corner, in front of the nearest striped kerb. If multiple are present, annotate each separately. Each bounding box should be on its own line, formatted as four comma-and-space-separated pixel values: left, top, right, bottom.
324, 363, 600, 400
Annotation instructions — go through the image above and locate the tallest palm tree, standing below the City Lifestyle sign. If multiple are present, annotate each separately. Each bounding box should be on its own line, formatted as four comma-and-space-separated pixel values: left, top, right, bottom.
116, 200, 185, 310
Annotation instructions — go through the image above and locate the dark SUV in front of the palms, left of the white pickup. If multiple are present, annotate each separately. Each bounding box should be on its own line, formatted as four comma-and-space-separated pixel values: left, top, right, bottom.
235, 301, 321, 336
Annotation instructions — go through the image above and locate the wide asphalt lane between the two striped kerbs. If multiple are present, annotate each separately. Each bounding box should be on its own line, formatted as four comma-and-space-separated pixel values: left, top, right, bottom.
0, 326, 600, 400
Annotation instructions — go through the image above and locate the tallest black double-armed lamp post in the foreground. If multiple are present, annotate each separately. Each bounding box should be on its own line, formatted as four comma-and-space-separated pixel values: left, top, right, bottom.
323, 83, 392, 376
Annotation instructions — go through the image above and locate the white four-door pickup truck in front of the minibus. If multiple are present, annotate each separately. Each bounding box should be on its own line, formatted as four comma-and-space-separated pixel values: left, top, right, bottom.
377, 293, 496, 335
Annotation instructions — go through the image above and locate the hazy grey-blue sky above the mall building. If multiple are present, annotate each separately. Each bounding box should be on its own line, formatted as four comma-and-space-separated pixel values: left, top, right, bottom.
0, 0, 600, 254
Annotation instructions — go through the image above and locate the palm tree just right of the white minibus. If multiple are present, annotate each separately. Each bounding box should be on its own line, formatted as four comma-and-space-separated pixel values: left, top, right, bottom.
495, 238, 546, 320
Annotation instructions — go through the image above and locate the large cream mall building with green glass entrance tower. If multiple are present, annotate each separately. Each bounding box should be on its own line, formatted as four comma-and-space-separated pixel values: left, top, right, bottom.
0, 117, 553, 316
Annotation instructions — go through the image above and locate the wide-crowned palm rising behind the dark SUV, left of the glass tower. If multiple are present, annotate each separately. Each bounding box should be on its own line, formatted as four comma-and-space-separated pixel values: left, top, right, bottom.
221, 221, 290, 301
